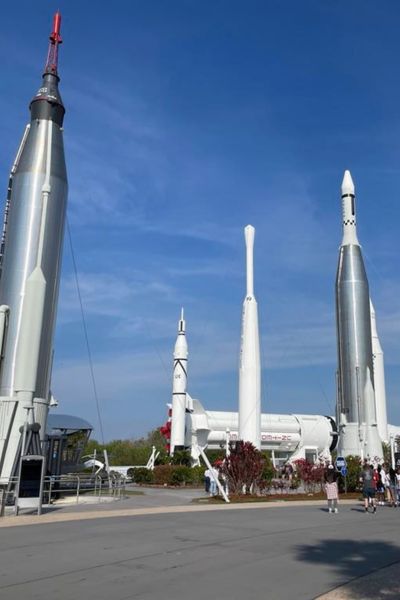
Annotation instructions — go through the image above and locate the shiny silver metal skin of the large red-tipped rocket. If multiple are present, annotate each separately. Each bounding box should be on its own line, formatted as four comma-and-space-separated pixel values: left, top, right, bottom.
0, 120, 67, 399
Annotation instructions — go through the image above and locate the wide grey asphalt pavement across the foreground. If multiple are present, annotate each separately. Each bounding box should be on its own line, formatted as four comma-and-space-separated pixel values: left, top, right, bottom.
0, 503, 400, 600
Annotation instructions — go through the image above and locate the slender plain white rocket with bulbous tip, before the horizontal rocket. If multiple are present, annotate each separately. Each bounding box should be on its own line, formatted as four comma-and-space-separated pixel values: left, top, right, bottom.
239, 225, 261, 449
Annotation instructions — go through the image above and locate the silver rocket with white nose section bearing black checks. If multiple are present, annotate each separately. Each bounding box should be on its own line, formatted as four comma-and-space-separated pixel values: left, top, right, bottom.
336, 171, 382, 460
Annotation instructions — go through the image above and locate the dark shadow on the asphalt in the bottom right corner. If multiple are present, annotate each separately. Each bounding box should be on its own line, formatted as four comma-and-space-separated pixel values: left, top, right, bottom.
296, 539, 400, 600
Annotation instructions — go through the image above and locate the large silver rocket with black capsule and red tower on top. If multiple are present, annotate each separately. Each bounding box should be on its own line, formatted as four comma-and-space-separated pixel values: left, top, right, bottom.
0, 13, 68, 478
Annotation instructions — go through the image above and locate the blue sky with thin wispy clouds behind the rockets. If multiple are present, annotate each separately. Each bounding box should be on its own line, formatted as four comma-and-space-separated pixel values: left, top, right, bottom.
0, 0, 400, 439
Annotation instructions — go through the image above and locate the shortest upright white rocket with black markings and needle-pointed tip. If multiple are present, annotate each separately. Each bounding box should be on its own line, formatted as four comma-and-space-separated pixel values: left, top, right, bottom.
170, 308, 188, 456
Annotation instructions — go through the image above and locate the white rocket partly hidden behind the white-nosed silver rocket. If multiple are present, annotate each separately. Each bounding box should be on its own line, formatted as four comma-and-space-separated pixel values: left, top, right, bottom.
370, 300, 389, 442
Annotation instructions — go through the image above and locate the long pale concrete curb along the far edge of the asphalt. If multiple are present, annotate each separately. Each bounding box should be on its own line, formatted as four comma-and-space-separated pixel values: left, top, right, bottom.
0, 500, 357, 528
